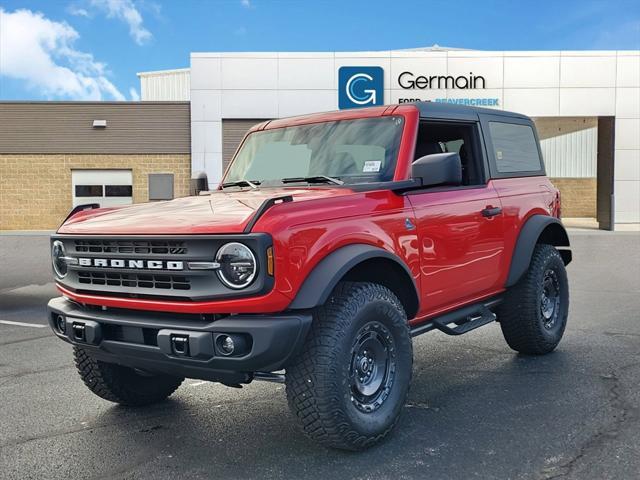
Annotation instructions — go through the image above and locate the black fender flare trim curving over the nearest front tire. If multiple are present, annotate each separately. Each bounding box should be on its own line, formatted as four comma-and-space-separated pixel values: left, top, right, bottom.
289, 243, 420, 318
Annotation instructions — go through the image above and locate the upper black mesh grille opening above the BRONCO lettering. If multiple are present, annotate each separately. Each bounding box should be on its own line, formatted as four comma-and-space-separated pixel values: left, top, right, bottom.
74, 239, 188, 255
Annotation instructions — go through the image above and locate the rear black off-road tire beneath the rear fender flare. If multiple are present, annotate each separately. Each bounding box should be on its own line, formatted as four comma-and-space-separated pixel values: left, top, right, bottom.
497, 244, 569, 355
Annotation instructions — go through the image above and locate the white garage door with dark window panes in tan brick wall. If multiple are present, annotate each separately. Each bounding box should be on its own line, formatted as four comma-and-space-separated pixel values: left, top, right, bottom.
71, 169, 133, 207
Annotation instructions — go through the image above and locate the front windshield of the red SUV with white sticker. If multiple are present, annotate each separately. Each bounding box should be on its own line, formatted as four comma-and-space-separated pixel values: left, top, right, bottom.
224, 116, 403, 184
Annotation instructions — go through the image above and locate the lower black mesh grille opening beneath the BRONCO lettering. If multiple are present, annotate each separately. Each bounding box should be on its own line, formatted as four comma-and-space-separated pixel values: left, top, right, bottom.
78, 271, 191, 290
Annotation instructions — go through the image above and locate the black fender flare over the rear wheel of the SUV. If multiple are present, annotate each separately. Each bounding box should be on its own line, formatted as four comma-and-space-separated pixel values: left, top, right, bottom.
505, 215, 571, 287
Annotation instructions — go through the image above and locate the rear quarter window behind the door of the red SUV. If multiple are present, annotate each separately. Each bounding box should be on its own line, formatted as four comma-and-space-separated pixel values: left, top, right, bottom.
489, 122, 542, 174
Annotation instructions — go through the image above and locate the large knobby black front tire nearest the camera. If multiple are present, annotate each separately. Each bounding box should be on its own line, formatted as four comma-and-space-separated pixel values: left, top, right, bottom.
286, 282, 413, 450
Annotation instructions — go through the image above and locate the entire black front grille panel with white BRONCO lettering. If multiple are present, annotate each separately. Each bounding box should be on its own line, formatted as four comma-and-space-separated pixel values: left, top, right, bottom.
52, 233, 274, 301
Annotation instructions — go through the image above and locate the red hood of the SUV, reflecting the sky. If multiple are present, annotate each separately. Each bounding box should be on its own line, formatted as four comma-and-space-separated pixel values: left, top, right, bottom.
58, 188, 353, 235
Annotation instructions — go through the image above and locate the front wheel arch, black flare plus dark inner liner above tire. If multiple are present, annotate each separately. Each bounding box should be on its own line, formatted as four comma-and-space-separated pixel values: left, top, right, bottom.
289, 244, 419, 319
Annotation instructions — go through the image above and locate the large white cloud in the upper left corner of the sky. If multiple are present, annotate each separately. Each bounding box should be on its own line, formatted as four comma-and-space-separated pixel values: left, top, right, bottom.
0, 8, 125, 100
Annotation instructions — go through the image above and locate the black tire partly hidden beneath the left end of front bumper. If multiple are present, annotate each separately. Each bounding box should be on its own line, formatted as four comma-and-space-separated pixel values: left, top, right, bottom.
73, 347, 184, 406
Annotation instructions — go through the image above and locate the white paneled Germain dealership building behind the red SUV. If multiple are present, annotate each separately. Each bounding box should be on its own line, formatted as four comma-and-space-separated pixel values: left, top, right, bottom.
139, 48, 640, 229
